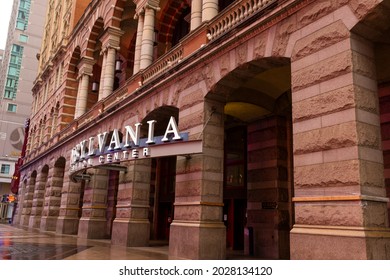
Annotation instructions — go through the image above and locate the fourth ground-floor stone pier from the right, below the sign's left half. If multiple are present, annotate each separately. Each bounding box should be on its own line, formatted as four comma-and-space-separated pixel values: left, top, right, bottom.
78, 169, 108, 239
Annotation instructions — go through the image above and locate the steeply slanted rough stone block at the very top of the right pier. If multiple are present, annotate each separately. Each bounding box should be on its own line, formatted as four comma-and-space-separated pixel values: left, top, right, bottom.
291, 20, 350, 61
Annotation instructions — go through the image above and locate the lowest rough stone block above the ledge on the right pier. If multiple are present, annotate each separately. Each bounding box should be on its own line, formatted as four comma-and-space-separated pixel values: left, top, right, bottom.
294, 160, 360, 188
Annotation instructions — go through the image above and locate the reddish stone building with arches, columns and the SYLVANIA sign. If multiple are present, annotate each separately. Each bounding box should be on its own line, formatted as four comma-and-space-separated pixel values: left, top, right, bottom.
14, 0, 390, 259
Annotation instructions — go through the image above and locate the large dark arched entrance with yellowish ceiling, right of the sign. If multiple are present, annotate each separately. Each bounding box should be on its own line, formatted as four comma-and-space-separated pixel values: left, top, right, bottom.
214, 58, 293, 259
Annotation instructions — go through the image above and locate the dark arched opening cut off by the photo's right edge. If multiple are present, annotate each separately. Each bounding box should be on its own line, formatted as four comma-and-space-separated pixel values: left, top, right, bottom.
351, 1, 390, 226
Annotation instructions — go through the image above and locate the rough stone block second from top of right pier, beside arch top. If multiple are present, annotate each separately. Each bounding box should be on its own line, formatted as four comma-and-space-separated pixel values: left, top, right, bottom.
291, 51, 352, 90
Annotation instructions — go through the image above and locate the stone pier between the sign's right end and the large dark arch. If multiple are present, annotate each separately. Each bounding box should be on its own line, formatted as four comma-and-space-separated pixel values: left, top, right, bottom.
169, 101, 226, 259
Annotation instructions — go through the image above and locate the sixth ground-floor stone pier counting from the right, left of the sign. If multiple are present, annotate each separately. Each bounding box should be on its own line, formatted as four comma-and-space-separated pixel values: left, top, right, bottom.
41, 165, 64, 231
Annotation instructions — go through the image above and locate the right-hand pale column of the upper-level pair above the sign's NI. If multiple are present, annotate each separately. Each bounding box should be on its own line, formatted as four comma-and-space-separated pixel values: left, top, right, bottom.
140, 4, 157, 70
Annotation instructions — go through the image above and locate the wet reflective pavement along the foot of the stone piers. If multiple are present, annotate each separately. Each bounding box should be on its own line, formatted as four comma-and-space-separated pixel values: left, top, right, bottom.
0, 224, 168, 260
